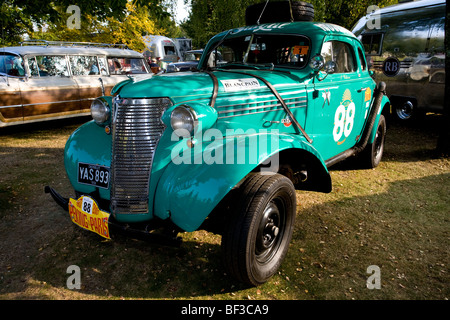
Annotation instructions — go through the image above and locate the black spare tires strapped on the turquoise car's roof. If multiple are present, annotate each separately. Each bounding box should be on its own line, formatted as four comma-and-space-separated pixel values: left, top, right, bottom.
245, 1, 314, 25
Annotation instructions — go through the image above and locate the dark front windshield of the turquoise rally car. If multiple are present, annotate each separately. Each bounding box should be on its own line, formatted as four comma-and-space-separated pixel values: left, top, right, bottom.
206, 34, 310, 69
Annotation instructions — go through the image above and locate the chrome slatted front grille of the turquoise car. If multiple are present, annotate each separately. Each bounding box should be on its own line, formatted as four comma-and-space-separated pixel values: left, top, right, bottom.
111, 98, 172, 214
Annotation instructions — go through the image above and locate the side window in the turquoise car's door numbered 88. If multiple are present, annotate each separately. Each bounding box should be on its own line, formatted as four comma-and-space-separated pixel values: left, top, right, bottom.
321, 40, 356, 73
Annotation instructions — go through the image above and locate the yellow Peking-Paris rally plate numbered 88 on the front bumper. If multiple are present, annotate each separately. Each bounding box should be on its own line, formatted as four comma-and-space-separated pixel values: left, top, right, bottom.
69, 196, 110, 239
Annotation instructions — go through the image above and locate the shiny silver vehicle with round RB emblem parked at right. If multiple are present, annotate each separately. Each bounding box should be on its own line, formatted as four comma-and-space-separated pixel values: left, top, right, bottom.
352, 0, 445, 120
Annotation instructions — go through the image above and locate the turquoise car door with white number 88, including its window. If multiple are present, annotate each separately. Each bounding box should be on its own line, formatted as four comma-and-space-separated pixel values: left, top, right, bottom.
310, 37, 366, 159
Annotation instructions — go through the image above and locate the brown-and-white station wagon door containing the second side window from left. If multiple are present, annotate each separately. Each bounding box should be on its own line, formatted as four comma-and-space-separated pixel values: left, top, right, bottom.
20, 55, 80, 121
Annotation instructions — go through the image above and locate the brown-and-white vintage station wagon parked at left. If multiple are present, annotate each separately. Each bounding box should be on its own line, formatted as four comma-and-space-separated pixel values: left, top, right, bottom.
0, 41, 150, 127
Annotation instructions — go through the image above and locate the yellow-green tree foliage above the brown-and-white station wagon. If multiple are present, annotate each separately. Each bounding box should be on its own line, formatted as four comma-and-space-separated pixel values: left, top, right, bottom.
0, 0, 181, 51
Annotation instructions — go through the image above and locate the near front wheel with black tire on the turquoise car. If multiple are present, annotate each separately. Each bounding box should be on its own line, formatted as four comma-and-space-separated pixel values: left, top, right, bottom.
222, 174, 296, 286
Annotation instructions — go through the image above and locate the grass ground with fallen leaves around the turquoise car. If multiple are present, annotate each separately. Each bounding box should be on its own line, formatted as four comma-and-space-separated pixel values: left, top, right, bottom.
0, 116, 450, 300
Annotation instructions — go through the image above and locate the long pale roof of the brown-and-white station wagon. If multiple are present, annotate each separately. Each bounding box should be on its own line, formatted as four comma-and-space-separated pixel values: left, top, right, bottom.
0, 45, 143, 58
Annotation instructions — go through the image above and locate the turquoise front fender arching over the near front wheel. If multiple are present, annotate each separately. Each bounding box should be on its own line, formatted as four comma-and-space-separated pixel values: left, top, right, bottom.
154, 133, 329, 232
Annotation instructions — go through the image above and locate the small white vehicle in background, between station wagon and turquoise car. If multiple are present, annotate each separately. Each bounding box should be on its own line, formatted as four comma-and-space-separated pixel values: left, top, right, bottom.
143, 35, 180, 70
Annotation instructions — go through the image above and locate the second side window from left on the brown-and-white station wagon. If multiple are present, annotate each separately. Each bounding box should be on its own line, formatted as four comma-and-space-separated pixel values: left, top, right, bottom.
28, 56, 69, 77
